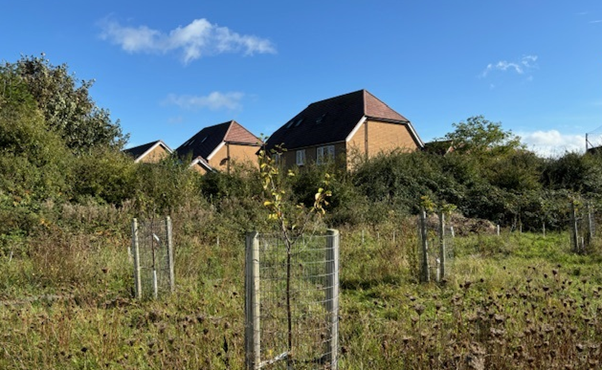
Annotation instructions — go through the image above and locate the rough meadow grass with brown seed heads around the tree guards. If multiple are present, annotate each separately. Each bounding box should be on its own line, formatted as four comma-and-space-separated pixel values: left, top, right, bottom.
0, 206, 602, 369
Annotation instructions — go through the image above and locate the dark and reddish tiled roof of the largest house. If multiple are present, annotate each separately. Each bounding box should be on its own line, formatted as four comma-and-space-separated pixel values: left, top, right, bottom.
266, 90, 422, 149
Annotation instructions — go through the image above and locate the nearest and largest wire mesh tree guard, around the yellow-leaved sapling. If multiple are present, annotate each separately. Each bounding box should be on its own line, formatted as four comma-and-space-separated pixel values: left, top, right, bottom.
245, 230, 339, 370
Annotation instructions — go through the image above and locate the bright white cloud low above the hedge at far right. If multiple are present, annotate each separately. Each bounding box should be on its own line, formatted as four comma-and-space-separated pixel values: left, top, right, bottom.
517, 130, 585, 157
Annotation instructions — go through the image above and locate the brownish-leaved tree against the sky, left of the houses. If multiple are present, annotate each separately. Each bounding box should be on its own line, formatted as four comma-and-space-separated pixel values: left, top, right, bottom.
0, 54, 127, 154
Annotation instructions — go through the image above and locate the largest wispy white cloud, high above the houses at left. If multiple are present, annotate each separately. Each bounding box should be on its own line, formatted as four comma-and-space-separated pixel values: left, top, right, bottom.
99, 18, 276, 63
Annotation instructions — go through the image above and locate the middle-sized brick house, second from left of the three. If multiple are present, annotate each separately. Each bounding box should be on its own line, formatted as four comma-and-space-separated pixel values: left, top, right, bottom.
176, 121, 261, 173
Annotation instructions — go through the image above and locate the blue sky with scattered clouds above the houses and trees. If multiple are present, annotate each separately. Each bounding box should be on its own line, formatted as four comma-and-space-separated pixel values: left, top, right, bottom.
0, 0, 602, 154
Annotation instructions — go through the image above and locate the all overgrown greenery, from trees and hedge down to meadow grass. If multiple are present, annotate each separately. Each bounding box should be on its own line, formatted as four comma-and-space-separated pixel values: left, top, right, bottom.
0, 57, 602, 369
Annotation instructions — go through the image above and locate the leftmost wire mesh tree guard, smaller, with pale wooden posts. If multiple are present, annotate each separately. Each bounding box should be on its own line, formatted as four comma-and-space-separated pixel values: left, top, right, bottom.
131, 216, 175, 299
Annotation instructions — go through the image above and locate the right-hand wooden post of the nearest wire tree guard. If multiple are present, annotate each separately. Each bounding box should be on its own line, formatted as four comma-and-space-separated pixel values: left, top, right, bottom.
326, 229, 339, 370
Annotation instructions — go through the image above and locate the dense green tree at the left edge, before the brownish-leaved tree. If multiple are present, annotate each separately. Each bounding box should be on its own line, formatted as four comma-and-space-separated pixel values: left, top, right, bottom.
0, 69, 71, 235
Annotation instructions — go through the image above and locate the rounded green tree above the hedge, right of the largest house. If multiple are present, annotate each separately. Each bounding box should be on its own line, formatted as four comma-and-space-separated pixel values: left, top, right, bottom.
445, 116, 522, 154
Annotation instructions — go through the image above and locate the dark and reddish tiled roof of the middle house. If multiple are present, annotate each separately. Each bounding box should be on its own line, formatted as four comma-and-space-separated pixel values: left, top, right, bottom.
176, 121, 260, 160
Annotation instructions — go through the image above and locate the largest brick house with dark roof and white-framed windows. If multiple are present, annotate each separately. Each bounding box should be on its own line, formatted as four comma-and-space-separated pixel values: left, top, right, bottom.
266, 90, 424, 168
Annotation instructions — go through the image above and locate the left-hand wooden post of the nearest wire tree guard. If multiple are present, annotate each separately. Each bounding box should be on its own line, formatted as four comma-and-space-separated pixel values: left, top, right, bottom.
245, 231, 261, 370
